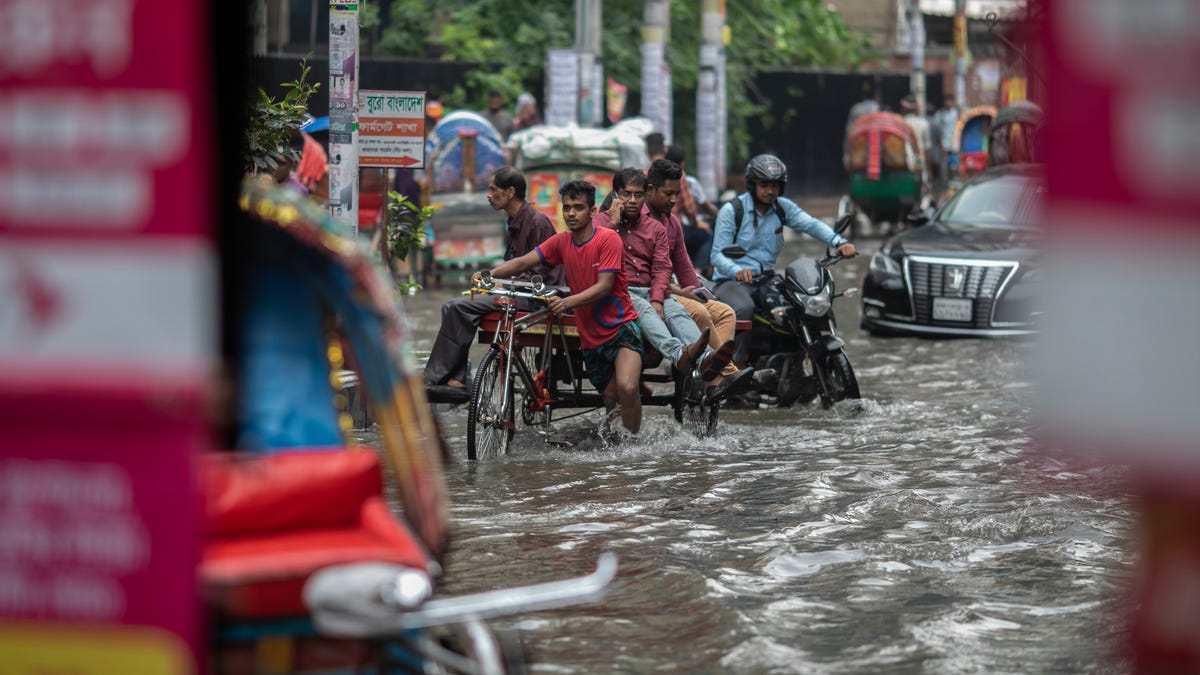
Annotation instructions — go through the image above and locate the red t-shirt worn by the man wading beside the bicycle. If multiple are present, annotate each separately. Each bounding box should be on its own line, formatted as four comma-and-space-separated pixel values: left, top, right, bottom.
535, 227, 637, 350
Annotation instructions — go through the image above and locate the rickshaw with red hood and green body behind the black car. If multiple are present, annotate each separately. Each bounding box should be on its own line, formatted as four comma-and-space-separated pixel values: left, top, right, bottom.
838, 112, 929, 238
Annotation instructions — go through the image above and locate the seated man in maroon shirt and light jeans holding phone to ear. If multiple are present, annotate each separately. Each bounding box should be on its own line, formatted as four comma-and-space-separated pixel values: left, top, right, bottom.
595, 167, 715, 378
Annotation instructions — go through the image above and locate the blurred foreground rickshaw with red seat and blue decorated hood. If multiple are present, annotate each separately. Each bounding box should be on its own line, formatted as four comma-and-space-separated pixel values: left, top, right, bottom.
200, 178, 616, 675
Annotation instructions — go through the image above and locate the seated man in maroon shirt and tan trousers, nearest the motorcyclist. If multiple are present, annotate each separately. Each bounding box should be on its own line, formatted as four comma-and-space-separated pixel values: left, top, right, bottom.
642, 159, 754, 399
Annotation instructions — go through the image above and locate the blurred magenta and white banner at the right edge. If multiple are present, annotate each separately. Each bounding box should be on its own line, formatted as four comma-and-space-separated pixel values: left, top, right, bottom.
1039, 0, 1200, 475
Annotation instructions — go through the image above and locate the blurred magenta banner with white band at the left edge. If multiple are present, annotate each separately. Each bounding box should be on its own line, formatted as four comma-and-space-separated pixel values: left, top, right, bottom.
0, 0, 216, 675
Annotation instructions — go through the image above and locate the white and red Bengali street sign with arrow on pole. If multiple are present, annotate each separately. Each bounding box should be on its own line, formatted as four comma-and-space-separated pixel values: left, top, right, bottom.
359, 89, 425, 168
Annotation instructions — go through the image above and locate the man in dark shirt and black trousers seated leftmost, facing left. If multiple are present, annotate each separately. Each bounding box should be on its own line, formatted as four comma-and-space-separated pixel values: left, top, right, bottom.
425, 167, 563, 402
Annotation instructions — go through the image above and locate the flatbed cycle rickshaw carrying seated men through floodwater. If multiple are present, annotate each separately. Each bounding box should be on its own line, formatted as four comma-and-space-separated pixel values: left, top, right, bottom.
467, 271, 734, 460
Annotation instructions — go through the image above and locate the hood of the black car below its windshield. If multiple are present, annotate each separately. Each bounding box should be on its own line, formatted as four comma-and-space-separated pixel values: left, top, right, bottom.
888, 222, 1038, 259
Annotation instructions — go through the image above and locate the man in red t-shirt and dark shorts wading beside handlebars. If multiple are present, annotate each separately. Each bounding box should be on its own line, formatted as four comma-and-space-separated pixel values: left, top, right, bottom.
480, 180, 642, 432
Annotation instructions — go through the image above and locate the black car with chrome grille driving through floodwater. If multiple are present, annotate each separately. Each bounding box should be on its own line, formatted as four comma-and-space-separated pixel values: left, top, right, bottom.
862, 165, 1045, 338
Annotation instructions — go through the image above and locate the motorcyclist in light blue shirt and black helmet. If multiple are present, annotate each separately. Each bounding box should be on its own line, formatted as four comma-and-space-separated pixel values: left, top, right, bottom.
712, 155, 858, 365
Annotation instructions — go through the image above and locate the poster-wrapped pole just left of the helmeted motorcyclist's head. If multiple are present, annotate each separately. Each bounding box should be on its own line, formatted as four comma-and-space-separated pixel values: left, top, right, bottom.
691, 0, 724, 196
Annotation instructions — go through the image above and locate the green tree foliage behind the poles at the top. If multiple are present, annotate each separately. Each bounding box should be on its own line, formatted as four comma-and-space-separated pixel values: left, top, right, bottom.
379, 0, 869, 162
